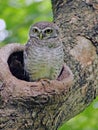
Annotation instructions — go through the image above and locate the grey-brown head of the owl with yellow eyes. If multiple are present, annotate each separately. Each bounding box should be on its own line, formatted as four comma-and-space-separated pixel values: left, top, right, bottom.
29, 22, 59, 40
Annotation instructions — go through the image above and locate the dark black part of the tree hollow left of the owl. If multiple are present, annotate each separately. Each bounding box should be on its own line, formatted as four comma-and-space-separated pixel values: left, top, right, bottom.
8, 51, 29, 81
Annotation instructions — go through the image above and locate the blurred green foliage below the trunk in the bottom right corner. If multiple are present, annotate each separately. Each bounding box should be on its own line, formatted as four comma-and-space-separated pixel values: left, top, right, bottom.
59, 98, 98, 130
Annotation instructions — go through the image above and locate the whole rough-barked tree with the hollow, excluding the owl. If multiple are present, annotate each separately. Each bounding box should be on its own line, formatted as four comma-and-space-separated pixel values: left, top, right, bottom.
0, 0, 98, 130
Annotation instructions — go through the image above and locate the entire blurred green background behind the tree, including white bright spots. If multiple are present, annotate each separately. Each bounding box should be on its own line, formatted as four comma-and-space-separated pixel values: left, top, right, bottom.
0, 0, 98, 130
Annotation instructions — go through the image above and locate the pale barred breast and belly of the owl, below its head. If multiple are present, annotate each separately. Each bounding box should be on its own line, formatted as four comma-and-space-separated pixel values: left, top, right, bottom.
26, 46, 63, 80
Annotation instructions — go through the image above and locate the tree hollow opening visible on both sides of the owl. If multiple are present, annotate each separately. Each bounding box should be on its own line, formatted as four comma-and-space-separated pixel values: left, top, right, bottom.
7, 51, 70, 81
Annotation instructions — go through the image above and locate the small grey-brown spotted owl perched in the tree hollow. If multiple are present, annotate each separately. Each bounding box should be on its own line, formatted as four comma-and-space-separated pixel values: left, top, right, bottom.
24, 22, 64, 81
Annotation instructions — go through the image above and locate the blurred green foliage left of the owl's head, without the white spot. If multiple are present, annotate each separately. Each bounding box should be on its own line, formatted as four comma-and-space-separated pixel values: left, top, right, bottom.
0, 0, 52, 45
